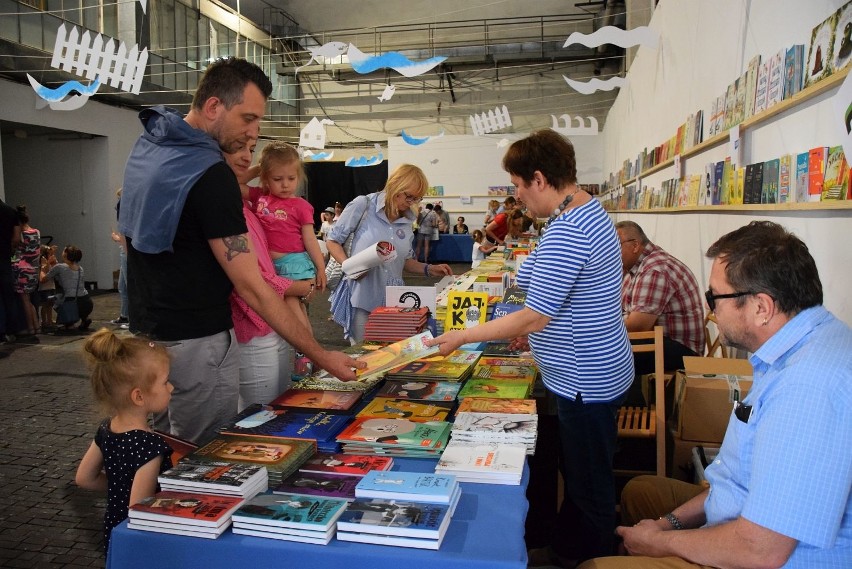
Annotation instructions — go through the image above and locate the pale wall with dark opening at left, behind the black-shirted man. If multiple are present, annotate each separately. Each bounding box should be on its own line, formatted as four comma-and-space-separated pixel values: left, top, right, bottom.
0, 80, 142, 288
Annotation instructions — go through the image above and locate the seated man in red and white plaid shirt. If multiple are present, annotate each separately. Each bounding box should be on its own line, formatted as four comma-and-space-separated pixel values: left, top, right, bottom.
615, 221, 705, 375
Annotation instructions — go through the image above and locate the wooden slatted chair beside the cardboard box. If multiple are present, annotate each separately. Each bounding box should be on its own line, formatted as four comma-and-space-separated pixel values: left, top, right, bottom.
618, 326, 666, 476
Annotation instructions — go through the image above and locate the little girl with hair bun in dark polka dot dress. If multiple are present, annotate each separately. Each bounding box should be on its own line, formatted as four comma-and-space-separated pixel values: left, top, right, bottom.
76, 328, 174, 551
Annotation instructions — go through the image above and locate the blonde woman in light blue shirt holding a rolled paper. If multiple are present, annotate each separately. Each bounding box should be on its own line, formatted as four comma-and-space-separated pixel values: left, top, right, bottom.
328, 164, 453, 344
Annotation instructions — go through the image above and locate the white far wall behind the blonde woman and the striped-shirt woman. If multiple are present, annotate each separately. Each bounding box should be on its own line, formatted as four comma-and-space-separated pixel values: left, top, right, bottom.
388, 134, 603, 227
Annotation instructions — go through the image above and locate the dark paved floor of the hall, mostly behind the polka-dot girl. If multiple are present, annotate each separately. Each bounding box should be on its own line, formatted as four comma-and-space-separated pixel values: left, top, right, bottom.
0, 265, 468, 569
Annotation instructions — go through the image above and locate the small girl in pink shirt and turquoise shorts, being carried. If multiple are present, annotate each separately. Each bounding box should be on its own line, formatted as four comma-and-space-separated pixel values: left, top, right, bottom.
248, 141, 326, 327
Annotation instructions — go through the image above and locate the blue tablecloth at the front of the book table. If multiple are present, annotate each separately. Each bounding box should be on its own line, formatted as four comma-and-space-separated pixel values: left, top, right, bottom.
107, 458, 529, 569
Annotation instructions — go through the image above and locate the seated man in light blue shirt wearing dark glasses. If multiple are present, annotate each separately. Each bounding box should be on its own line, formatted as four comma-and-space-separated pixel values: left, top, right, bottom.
581, 221, 852, 569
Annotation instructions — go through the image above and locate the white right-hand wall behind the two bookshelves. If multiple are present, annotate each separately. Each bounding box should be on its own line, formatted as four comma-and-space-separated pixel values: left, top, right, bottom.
602, 0, 852, 323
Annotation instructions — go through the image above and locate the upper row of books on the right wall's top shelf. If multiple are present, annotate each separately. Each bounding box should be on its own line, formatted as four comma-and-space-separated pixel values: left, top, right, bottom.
602, 2, 852, 193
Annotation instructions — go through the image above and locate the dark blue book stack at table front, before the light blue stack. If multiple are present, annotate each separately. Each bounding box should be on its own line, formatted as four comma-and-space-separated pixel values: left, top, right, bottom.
337, 498, 451, 540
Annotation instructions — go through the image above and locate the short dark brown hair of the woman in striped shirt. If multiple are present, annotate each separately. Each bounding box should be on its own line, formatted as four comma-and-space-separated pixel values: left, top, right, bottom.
503, 128, 577, 189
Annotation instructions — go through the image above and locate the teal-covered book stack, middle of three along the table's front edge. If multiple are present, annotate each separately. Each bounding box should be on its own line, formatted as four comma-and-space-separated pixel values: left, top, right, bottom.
231, 493, 349, 533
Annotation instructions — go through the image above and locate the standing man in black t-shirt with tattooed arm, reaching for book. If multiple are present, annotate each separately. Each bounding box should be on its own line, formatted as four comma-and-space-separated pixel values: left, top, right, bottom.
118, 57, 364, 443
